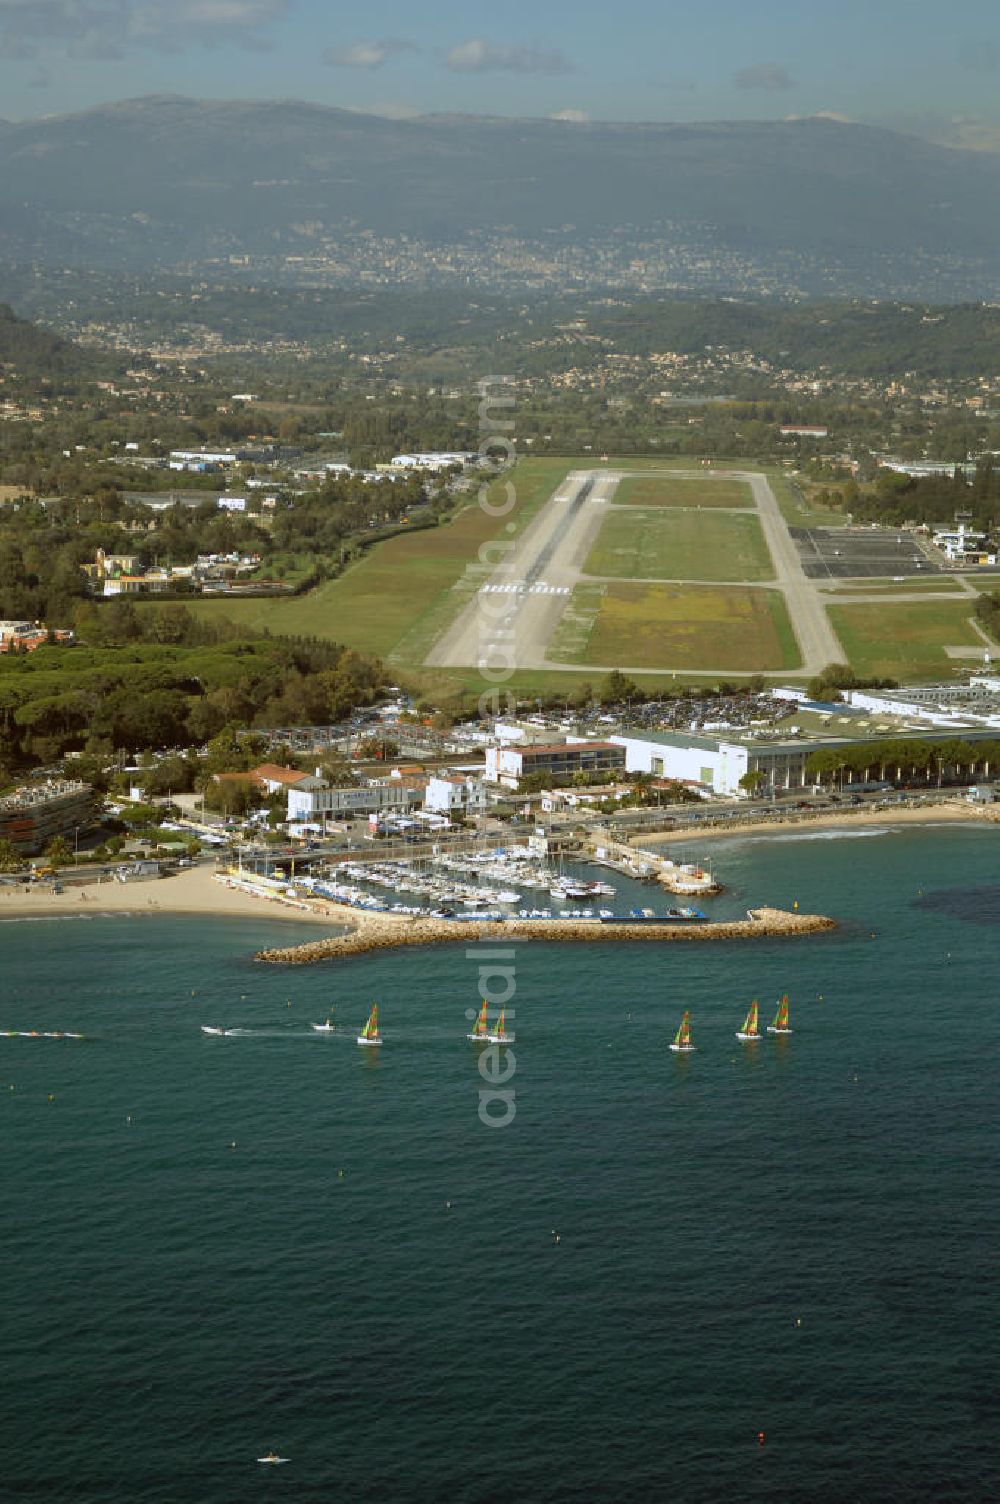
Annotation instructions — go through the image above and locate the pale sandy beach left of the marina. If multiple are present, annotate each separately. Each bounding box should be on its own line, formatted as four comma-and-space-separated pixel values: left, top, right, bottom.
0, 866, 341, 929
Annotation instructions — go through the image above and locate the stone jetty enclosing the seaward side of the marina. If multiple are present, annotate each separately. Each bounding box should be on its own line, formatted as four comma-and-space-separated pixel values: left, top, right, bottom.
254, 904, 836, 966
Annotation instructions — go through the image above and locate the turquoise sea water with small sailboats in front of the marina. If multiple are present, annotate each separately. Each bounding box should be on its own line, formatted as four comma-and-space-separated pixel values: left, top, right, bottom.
0, 827, 1000, 1504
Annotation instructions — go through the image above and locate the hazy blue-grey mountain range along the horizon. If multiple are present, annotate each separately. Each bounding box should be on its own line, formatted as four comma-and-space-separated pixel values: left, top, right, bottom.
0, 98, 1000, 298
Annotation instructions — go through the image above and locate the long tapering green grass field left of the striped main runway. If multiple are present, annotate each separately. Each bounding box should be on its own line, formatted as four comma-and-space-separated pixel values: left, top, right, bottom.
175, 459, 571, 666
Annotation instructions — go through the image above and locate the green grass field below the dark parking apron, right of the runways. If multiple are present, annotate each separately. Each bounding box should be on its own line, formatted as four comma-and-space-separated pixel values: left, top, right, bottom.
829, 596, 985, 680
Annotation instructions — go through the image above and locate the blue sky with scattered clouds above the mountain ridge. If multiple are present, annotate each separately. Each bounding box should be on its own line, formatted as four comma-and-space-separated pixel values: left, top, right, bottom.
0, 0, 1000, 150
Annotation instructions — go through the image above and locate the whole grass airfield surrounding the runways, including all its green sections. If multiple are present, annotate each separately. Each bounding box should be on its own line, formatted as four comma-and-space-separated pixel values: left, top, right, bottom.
175, 456, 995, 698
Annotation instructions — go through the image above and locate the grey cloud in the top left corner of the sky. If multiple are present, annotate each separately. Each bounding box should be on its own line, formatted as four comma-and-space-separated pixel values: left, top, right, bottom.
0, 0, 298, 59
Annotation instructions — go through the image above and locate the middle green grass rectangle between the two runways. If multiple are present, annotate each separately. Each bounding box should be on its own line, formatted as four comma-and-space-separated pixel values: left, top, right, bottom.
585, 508, 774, 584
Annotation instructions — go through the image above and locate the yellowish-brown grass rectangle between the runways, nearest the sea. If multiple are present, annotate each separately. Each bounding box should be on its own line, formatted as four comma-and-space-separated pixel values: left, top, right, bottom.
547, 582, 802, 675
